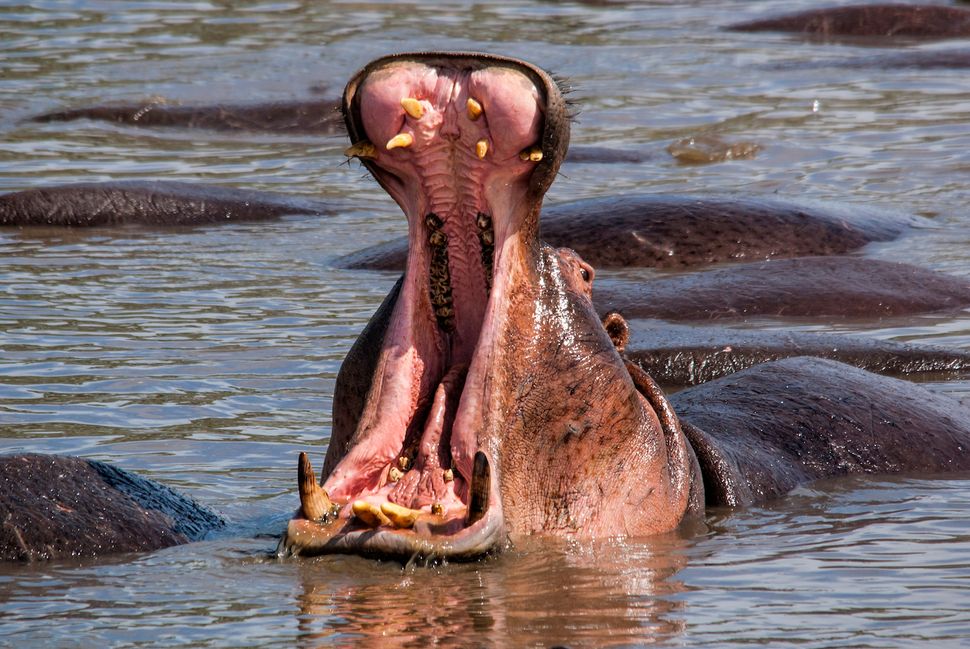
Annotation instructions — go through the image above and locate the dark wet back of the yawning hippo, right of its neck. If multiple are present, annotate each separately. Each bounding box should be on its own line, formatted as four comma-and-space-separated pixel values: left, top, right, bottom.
671, 357, 970, 506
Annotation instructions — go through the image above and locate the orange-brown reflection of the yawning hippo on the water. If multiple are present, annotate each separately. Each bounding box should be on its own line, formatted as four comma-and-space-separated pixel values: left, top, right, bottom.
290, 539, 686, 647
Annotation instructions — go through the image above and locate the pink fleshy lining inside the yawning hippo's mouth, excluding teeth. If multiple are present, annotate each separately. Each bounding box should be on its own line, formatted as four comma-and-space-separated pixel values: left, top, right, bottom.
323, 61, 543, 523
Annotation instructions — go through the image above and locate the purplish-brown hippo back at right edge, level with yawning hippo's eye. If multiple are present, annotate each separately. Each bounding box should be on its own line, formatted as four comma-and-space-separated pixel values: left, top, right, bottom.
594, 257, 970, 322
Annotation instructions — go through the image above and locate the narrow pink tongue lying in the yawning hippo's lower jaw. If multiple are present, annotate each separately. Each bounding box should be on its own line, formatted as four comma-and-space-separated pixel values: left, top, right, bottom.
387, 365, 468, 509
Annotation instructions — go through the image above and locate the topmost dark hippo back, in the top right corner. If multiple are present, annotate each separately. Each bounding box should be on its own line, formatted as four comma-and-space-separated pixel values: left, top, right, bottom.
728, 4, 970, 38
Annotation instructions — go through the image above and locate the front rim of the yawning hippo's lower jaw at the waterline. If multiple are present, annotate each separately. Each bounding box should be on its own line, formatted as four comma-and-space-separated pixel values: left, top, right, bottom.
277, 504, 508, 561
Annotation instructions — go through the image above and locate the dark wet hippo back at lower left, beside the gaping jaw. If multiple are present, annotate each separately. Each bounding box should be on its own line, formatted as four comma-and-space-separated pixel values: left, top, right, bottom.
0, 455, 225, 561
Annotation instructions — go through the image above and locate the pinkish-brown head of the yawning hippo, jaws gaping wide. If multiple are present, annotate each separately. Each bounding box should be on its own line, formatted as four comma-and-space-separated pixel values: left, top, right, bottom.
281, 53, 692, 558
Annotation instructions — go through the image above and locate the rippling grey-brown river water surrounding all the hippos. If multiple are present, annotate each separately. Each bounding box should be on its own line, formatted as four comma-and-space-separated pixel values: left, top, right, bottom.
0, 0, 970, 647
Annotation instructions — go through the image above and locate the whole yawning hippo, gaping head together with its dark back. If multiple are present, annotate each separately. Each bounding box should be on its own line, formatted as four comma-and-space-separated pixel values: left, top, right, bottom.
279, 53, 970, 558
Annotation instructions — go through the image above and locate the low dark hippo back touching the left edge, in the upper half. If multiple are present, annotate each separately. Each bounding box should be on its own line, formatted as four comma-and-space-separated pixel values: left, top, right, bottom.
0, 181, 329, 227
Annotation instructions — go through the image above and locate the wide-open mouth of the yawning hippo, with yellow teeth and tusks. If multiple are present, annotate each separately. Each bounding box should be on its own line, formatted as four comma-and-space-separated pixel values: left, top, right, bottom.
281, 53, 568, 558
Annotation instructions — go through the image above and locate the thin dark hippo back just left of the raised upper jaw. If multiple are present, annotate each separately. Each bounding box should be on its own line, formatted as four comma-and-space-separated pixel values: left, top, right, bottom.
33, 99, 343, 135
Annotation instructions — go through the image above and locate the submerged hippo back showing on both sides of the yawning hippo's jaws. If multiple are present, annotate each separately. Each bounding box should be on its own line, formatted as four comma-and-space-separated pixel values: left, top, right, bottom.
334, 195, 926, 270
